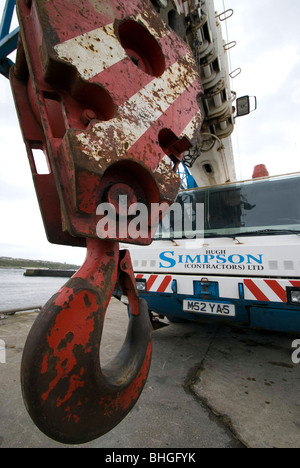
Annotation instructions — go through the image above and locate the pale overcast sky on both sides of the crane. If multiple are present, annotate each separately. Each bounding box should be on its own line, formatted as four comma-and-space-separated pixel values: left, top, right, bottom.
0, 0, 300, 264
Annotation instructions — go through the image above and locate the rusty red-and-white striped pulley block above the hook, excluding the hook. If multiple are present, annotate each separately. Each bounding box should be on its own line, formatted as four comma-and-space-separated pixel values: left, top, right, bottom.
10, 0, 203, 245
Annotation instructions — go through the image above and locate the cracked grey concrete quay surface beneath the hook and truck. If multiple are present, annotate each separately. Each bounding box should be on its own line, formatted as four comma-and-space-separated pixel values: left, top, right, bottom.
0, 299, 300, 449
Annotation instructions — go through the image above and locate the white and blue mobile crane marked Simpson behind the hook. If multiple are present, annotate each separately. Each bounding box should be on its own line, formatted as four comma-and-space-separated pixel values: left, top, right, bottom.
124, 2, 300, 340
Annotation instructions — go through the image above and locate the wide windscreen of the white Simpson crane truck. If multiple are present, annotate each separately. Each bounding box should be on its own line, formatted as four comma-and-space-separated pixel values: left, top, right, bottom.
155, 176, 300, 239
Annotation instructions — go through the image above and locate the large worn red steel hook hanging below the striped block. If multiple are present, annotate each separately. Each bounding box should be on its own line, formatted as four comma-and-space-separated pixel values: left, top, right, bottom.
21, 239, 152, 444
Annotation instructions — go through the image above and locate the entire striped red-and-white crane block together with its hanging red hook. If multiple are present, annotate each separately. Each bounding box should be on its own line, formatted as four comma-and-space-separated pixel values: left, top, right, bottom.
10, 0, 203, 444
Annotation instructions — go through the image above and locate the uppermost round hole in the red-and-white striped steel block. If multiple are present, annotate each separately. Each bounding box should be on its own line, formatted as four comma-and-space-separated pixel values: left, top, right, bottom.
119, 20, 166, 76
